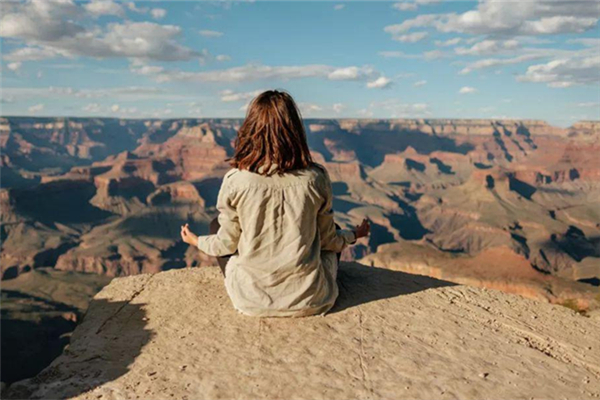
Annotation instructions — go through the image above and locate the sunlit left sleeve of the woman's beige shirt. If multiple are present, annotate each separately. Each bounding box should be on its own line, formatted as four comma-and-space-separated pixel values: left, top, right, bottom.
198, 178, 242, 257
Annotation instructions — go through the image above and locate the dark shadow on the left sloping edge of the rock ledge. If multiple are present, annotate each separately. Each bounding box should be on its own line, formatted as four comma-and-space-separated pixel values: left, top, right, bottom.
2, 296, 153, 399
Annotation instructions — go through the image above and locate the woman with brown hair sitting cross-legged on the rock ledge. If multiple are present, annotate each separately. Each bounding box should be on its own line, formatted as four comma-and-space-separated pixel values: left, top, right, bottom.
181, 90, 370, 317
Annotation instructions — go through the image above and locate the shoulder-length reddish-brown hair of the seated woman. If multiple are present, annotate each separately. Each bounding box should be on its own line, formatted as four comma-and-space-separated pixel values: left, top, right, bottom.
229, 90, 313, 176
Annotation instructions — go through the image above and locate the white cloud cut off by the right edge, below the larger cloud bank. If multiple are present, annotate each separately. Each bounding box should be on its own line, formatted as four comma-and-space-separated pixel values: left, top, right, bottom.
517, 55, 600, 88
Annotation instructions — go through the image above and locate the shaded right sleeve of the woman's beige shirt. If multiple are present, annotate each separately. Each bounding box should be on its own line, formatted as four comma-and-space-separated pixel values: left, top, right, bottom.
317, 168, 356, 253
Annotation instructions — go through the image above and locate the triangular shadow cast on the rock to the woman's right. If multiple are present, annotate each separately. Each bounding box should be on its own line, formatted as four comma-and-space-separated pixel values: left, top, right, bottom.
330, 263, 456, 313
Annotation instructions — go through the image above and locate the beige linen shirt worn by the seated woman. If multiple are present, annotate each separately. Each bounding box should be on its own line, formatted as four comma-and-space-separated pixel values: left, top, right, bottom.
198, 164, 356, 317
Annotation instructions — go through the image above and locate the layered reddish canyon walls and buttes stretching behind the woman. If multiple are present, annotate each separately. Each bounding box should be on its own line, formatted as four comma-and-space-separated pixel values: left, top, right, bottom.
0, 117, 600, 308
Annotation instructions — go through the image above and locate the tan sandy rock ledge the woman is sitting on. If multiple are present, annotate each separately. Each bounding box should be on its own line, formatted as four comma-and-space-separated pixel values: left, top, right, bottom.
8, 264, 600, 399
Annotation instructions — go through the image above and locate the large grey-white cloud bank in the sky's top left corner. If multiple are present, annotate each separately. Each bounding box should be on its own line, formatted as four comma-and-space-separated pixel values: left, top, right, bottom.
0, 0, 201, 61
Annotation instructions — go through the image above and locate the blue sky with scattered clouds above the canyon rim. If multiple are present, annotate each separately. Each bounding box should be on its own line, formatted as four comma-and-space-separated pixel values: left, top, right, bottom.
0, 0, 600, 126
